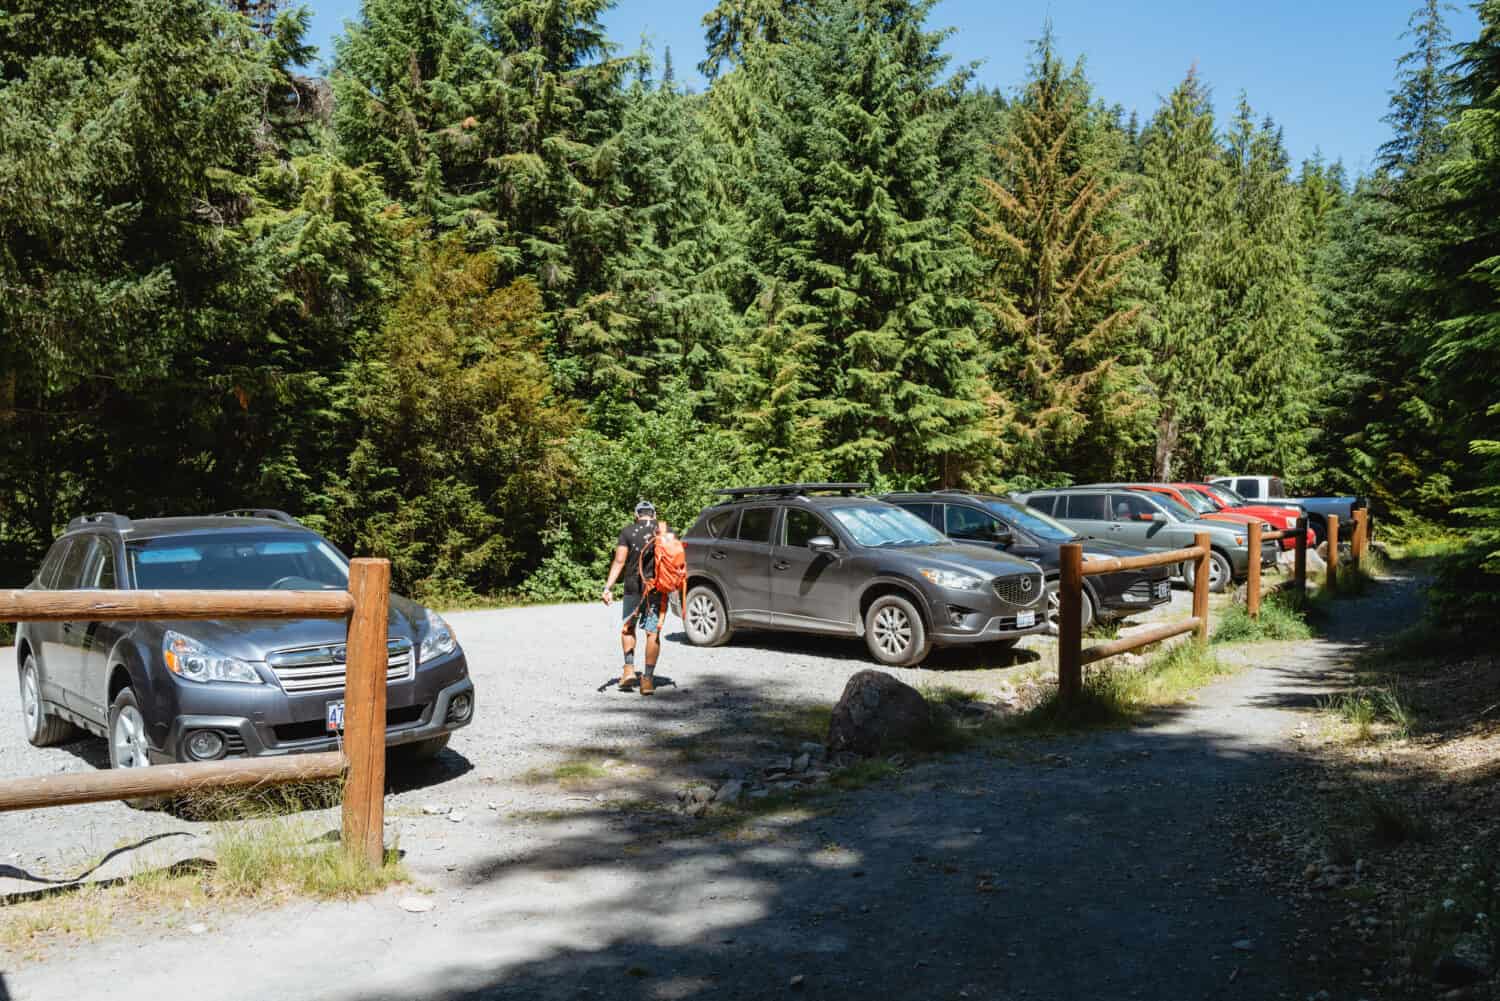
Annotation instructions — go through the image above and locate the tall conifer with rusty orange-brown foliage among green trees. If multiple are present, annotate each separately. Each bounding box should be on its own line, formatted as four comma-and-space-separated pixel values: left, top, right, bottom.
977, 38, 1149, 482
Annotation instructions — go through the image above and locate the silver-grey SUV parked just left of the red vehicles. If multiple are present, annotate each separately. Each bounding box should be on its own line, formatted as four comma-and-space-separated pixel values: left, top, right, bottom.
1019, 488, 1277, 591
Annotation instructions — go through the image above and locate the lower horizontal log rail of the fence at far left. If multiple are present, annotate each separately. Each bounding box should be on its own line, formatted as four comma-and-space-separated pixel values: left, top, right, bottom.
0, 750, 345, 813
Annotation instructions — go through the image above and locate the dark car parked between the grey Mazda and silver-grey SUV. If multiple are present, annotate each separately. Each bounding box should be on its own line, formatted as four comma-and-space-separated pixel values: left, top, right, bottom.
881, 491, 1172, 629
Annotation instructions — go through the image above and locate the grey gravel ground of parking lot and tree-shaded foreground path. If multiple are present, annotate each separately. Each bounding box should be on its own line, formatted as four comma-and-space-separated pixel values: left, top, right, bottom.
0, 564, 1380, 1001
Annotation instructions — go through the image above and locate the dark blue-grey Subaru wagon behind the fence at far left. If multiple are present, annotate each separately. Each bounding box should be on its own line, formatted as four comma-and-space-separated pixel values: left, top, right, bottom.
17, 510, 474, 768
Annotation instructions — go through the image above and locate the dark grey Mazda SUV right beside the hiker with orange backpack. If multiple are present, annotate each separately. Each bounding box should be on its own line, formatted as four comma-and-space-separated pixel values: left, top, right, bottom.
684, 483, 1047, 666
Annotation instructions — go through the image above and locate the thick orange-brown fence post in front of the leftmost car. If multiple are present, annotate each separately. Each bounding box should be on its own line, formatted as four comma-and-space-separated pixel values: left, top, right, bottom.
344, 560, 390, 866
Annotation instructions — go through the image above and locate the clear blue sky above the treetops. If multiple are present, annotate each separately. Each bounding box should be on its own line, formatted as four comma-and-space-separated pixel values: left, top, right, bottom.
306, 0, 1478, 173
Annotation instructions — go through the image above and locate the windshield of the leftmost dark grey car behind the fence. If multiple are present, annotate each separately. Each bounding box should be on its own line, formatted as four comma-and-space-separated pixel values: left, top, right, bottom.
126, 531, 350, 591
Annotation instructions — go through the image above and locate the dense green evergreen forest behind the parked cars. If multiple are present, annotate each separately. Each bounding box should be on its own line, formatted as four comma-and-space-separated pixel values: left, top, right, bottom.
0, 0, 1500, 623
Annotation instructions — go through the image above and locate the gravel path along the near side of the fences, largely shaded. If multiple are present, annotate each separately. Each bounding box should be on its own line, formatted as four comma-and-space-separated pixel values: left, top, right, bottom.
0, 578, 1421, 1001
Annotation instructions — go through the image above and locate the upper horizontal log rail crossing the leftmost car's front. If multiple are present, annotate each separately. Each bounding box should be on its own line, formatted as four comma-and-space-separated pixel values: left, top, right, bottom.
0, 590, 354, 623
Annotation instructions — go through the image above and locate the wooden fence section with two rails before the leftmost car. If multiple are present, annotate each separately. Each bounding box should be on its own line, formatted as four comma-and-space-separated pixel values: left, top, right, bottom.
0, 560, 390, 864
